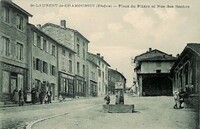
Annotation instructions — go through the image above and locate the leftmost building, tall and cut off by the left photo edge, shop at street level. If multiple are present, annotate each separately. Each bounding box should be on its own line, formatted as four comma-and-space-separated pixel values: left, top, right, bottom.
0, 0, 32, 101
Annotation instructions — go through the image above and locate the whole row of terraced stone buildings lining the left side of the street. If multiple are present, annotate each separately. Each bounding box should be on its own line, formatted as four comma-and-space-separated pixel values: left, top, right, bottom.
0, 0, 126, 101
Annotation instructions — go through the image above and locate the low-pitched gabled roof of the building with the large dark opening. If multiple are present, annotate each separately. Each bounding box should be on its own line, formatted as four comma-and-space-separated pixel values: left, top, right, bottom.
134, 49, 177, 62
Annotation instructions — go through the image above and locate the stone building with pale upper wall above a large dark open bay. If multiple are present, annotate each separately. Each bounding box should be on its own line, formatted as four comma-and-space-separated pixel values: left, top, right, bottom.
134, 48, 177, 96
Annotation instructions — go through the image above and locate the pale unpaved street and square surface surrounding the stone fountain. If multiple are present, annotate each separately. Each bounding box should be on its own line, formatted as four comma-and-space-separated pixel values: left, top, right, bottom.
0, 95, 198, 129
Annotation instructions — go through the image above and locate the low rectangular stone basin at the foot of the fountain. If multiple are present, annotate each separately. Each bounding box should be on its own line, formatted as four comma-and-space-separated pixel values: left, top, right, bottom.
103, 104, 134, 113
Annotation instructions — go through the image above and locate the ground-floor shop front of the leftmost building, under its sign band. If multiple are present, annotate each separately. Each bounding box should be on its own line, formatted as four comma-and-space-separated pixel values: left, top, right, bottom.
0, 62, 27, 101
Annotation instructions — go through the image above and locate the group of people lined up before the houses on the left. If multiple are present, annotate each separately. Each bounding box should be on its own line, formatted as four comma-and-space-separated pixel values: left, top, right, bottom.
13, 87, 52, 106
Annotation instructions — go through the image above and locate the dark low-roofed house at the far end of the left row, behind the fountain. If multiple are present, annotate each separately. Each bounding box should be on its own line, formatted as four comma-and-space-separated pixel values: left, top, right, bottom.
108, 68, 126, 94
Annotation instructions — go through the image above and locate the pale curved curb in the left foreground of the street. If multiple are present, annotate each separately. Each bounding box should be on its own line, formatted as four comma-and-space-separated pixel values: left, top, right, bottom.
25, 112, 69, 129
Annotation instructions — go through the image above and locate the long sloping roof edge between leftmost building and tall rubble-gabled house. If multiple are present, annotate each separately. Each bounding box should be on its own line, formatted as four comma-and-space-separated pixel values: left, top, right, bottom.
28, 23, 76, 53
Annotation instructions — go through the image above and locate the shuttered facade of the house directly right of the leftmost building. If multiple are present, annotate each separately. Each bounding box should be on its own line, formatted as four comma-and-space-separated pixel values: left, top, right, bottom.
28, 24, 58, 100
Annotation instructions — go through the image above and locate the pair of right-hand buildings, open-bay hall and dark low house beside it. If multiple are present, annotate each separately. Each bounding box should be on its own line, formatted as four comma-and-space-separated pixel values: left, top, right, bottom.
134, 43, 200, 107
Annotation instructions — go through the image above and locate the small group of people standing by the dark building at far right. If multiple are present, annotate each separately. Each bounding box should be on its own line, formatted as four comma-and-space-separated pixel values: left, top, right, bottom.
173, 88, 189, 109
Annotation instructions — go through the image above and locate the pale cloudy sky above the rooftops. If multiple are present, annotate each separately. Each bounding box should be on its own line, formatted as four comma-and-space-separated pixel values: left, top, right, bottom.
12, 0, 200, 87
